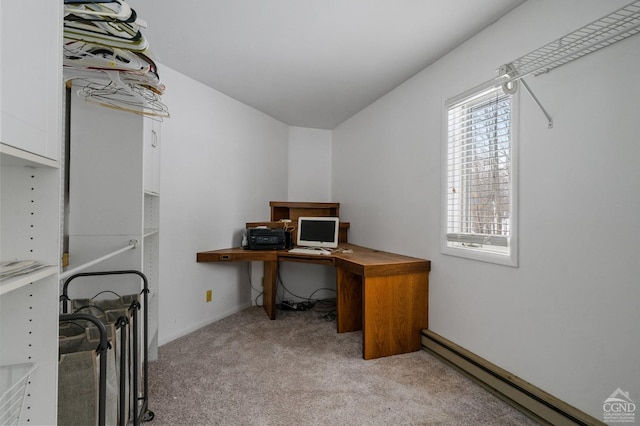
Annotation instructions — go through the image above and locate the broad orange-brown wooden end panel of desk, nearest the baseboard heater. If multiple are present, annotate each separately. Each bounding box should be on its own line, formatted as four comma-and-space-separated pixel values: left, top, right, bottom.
362, 272, 429, 359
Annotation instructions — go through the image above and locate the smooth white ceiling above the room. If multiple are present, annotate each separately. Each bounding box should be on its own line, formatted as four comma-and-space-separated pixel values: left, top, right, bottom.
127, 0, 525, 129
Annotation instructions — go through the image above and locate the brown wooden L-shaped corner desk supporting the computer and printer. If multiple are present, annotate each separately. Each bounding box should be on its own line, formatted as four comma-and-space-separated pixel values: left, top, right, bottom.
196, 244, 431, 359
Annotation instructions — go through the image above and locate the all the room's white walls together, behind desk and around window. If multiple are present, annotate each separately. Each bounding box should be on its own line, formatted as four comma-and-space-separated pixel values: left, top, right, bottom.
154, 0, 640, 418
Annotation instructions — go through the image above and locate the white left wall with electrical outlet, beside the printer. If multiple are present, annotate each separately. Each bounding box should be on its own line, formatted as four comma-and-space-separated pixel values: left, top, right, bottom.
159, 67, 289, 345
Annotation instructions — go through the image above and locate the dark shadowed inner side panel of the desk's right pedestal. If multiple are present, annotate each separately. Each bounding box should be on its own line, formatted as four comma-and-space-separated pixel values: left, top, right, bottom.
336, 268, 362, 333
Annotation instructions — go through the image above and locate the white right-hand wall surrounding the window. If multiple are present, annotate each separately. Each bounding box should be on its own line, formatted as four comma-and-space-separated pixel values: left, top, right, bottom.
332, 0, 640, 419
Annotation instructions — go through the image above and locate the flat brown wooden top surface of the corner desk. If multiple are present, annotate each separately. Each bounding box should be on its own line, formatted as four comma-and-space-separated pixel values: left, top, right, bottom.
196, 244, 431, 276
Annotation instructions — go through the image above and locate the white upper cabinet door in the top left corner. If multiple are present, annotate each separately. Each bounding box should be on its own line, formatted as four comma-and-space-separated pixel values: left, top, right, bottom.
0, 0, 62, 160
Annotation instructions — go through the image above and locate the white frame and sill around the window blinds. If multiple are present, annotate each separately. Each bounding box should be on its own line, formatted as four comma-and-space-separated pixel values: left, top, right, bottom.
440, 86, 519, 267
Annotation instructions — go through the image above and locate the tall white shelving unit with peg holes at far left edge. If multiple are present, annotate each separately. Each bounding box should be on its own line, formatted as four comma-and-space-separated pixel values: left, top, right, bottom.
0, 0, 63, 425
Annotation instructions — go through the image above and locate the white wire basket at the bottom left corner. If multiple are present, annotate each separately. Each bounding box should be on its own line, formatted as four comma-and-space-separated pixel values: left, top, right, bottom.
0, 364, 37, 425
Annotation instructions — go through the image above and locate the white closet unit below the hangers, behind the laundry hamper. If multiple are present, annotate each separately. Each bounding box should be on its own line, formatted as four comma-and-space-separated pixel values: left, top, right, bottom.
67, 86, 160, 360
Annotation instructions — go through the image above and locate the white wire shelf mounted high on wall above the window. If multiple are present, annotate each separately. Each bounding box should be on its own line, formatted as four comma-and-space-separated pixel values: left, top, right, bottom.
511, 1, 640, 78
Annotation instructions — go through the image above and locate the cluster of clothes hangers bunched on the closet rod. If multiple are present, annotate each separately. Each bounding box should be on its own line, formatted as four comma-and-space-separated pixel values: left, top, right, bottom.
63, 0, 169, 118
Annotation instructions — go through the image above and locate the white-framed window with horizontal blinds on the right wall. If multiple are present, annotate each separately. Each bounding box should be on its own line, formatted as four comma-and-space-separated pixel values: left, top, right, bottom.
443, 87, 517, 266
